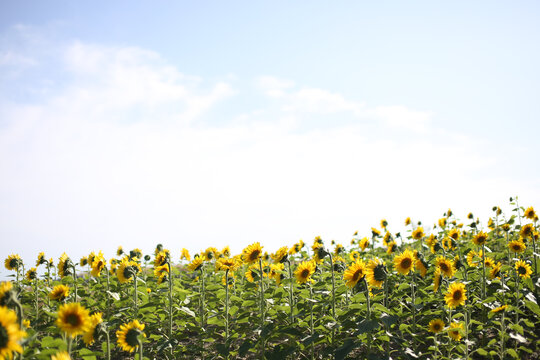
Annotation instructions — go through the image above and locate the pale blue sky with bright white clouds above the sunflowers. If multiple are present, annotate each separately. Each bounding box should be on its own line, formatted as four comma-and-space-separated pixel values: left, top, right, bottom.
0, 1, 540, 276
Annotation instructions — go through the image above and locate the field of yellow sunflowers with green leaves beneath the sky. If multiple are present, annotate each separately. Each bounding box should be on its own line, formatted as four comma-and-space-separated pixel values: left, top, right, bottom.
0, 199, 540, 359
